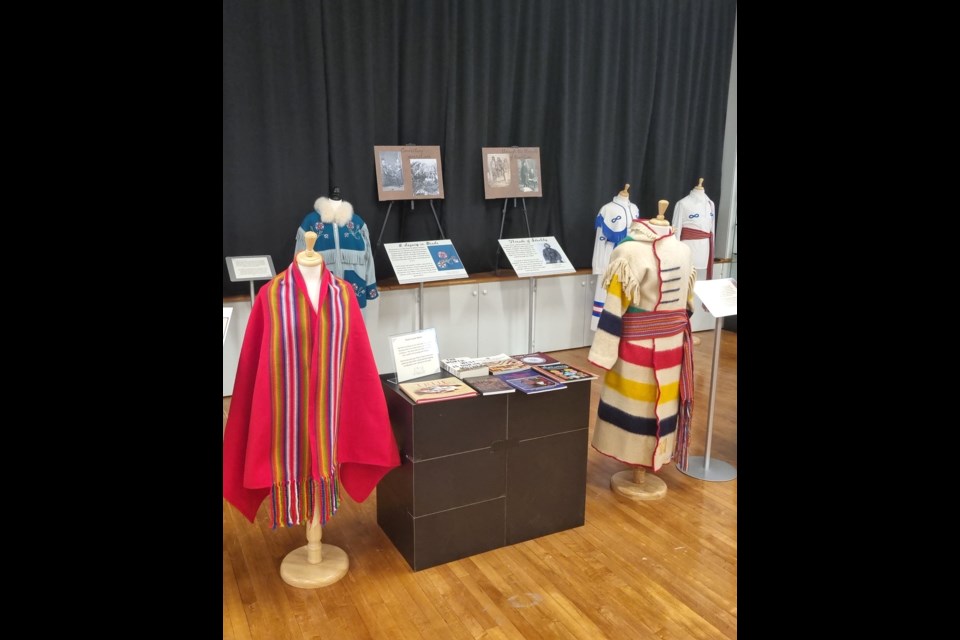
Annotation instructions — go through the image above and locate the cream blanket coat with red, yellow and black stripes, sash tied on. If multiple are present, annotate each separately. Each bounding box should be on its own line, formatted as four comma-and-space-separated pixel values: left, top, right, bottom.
588, 221, 697, 471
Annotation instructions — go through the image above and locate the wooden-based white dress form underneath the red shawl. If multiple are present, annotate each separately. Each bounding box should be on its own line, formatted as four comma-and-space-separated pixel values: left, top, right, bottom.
280, 231, 350, 589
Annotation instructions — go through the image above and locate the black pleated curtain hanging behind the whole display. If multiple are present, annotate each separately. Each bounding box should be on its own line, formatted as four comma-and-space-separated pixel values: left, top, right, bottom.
221, 0, 737, 296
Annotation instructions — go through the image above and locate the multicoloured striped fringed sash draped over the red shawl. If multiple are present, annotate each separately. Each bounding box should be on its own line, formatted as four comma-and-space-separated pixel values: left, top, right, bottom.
267, 265, 350, 528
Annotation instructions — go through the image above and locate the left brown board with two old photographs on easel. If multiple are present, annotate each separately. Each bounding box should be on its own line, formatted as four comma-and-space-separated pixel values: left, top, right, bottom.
373, 145, 443, 202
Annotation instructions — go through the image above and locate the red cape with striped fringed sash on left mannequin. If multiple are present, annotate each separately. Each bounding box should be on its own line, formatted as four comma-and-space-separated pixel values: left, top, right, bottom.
223, 264, 400, 527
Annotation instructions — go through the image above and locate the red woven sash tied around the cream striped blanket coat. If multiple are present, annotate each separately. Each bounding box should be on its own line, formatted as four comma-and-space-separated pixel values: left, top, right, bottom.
622, 309, 693, 469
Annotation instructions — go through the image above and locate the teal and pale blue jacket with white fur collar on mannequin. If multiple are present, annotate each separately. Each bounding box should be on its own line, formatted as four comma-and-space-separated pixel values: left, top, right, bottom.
295, 187, 380, 309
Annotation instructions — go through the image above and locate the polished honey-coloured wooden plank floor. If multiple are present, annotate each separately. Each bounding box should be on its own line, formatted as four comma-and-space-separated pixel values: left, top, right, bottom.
223, 331, 737, 640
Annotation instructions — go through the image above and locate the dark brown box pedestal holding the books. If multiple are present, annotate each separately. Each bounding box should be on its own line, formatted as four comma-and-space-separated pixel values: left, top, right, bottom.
377, 374, 590, 571
